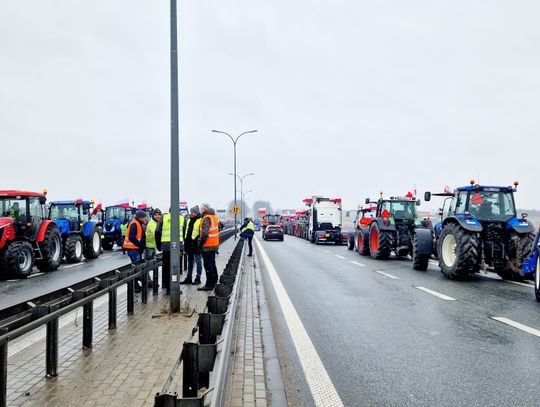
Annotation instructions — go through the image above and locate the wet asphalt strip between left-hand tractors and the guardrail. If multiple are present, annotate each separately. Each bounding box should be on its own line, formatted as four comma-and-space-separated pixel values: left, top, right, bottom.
0, 250, 129, 309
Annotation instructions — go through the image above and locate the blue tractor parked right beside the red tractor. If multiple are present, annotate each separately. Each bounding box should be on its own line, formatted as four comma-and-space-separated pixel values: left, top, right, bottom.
49, 199, 101, 263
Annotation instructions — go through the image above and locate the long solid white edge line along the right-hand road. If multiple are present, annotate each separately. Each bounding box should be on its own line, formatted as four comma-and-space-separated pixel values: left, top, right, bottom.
255, 238, 343, 407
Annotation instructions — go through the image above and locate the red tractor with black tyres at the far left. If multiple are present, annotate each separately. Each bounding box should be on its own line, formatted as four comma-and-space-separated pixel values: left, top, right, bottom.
0, 190, 62, 278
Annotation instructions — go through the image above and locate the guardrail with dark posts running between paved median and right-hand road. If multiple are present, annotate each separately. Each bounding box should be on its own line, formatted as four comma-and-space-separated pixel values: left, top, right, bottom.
154, 238, 244, 407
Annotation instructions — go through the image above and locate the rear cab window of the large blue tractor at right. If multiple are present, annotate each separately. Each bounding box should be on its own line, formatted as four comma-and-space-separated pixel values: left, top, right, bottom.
469, 191, 516, 222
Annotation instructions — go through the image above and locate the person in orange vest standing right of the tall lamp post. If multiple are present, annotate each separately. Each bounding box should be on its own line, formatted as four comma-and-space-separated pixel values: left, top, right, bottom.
197, 204, 219, 291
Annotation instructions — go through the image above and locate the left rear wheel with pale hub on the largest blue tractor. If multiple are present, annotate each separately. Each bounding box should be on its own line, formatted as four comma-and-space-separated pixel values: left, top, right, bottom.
437, 223, 480, 279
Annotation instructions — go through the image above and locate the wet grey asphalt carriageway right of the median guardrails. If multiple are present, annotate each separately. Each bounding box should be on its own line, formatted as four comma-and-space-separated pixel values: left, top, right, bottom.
258, 236, 540, 406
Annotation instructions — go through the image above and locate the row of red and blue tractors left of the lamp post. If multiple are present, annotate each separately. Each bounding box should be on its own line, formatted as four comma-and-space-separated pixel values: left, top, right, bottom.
0, 190, 151, 279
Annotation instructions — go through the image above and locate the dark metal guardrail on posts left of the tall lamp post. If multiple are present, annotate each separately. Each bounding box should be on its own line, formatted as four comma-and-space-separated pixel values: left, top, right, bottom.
0, 230, 234, 407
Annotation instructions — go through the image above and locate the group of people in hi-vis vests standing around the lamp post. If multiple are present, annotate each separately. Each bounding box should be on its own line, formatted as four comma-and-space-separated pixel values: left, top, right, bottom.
123, 204, 220, 294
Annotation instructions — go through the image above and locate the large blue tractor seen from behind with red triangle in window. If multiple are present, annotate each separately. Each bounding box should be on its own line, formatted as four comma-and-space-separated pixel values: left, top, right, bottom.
424, 180, 534, 281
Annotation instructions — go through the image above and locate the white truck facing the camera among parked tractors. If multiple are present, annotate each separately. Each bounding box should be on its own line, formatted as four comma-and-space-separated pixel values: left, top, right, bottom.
304, 196, 349, 245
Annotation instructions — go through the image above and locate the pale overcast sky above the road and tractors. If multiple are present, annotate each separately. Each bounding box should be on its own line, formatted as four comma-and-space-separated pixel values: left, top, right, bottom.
0, 0, 540, 214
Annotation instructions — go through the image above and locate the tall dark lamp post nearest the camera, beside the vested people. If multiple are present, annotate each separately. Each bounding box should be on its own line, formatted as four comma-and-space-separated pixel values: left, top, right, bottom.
170, 0, 180, 313
